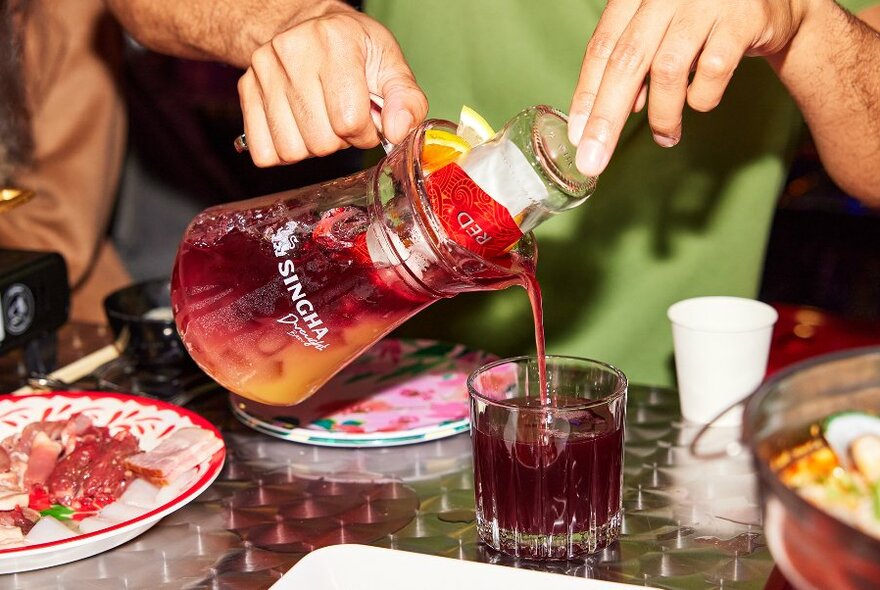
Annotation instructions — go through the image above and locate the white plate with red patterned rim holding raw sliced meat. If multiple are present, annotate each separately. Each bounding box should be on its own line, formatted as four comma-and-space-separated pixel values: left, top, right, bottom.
0, 392, 226, 574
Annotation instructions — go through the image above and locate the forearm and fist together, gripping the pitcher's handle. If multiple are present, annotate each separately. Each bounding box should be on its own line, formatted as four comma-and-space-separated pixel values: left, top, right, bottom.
107, 0, 428, 166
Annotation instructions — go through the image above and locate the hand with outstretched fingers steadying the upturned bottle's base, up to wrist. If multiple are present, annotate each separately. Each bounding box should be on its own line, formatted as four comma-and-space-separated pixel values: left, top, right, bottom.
569, 0, 811, 176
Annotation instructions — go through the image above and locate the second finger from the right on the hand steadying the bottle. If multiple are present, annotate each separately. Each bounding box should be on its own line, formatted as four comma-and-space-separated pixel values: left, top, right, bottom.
648, 14, 714, 147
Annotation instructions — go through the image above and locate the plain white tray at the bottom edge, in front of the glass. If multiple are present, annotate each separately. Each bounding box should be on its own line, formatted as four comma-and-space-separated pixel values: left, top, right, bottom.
270, 545, 656, 590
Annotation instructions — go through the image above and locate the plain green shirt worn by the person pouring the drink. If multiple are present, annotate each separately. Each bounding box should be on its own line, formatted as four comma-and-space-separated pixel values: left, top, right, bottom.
365, 0, 876, 385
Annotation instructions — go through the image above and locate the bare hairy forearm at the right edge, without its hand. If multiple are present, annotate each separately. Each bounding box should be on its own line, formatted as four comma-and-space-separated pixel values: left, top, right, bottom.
769, 0, 880, 207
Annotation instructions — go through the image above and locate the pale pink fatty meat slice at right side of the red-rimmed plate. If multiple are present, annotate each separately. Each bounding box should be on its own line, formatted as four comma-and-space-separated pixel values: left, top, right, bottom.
125, 427, 223, 486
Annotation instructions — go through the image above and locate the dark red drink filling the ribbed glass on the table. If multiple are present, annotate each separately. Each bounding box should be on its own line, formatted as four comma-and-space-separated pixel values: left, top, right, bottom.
472, 398, 623, 559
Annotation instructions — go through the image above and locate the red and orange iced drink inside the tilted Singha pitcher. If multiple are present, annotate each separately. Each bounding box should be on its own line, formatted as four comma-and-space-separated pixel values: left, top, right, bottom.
172, 200, 434, 405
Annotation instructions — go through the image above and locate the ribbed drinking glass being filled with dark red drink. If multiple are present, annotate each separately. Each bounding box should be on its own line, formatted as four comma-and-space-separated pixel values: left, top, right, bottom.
468, 356, 627, 559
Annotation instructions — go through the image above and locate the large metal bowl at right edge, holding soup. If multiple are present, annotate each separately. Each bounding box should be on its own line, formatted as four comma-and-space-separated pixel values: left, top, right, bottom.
743, 347, 880, 590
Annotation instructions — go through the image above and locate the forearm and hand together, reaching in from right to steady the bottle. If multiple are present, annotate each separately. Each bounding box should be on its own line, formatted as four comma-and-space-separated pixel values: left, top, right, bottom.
569, 0, 880, 205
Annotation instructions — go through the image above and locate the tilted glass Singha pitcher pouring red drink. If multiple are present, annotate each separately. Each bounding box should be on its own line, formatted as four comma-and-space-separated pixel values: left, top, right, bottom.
171, 120, 536, 405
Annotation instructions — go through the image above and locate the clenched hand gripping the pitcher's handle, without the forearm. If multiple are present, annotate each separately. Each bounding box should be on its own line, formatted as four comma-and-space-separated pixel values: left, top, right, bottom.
238, 10, 428, 167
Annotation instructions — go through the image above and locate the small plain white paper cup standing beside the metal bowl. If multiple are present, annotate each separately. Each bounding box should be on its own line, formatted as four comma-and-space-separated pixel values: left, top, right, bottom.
667, 297, 778, 426
